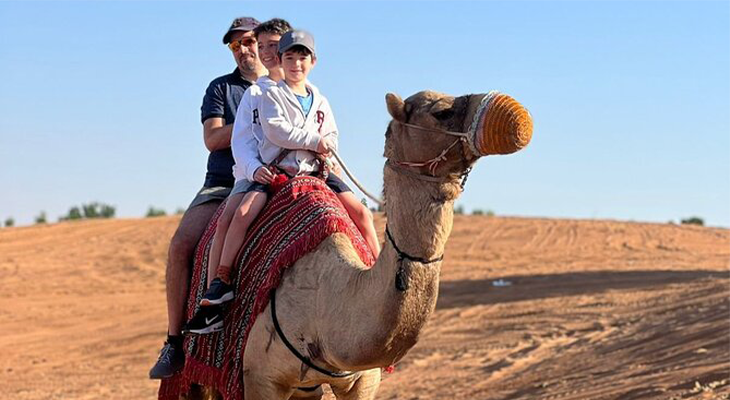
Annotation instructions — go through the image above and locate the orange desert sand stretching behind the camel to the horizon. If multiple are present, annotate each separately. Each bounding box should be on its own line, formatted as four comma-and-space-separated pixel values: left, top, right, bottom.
0, 216, 730, 400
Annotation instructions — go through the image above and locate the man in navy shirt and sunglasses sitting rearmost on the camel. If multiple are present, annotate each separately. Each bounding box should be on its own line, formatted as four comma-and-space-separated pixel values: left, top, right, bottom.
150, 17, 266, 379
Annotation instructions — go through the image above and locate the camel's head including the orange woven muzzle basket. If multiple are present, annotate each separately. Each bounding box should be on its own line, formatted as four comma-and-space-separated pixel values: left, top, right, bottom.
384, 91, 532, 200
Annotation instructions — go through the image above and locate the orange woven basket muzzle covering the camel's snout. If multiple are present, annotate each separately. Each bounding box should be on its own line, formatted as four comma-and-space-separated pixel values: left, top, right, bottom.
471, 91, 532, 156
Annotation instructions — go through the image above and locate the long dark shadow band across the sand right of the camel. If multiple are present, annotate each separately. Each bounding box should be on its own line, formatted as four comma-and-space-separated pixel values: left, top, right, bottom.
436, 270, 730, 309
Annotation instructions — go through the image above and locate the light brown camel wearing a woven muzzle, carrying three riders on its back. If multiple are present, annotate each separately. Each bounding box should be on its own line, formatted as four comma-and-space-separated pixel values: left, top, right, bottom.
188, 91, 532, 400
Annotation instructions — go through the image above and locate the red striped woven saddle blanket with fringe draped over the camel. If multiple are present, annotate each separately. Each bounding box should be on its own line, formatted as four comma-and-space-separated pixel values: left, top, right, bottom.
158, 177, 375, 400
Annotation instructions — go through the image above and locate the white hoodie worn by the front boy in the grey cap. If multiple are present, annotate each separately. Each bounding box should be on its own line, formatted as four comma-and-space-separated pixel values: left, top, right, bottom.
259, 80, 338, 176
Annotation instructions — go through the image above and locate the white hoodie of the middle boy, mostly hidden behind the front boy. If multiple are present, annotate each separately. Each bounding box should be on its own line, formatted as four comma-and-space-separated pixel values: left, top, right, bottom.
231, 76, 276, 182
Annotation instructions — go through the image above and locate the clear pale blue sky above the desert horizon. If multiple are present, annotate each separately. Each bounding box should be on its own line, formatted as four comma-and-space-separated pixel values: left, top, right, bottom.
0, 1, 730, 227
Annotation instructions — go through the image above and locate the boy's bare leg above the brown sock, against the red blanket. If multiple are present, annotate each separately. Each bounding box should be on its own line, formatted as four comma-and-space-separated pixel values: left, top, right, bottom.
218, 191, 267, 284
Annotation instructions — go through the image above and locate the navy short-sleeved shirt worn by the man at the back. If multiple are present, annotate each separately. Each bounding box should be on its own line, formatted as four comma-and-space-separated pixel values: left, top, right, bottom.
200, 68, 251, 187
